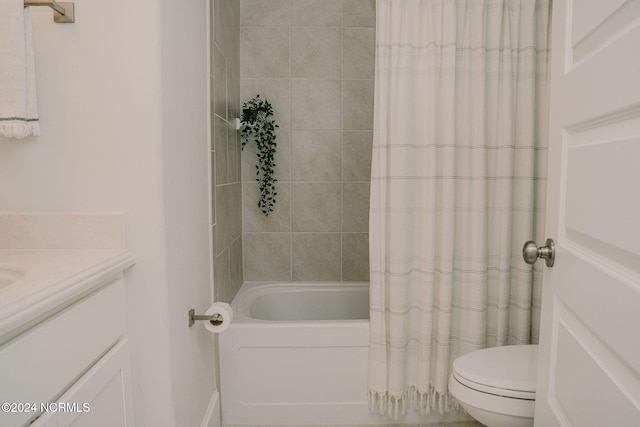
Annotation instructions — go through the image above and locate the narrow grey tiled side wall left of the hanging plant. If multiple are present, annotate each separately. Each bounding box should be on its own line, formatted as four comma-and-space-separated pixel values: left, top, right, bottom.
210, 0, 243, 302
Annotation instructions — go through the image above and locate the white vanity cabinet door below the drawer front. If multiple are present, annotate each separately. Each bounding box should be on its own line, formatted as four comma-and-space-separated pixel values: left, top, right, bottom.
32, 340, 134, 427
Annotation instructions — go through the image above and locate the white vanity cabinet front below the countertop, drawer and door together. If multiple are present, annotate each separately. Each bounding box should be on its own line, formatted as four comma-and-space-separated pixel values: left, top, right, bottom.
0, 274, 133, 427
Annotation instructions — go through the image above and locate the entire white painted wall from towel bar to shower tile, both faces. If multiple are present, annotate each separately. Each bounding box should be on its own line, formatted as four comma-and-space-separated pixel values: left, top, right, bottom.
0, 0, 215, 426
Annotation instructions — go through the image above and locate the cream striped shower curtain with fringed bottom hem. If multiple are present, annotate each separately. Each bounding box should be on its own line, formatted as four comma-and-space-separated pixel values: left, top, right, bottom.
369, 0, 550, 418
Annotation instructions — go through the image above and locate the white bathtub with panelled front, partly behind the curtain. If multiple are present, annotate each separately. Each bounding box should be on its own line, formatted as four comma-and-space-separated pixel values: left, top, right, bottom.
219, 282, 469, 426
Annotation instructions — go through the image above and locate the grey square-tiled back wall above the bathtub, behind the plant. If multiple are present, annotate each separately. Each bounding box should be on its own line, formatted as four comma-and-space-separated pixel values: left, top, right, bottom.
239, 0, 375, 281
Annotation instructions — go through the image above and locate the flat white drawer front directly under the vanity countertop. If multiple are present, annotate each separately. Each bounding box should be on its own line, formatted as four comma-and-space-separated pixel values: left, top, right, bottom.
0, 280, 125, 426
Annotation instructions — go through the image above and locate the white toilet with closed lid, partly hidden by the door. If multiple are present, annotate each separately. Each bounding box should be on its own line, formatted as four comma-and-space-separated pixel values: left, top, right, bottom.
449, 345, 538, 427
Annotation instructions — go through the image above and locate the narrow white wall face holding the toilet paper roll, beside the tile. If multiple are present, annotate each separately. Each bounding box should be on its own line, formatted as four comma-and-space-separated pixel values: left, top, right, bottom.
161, 0, 215, 426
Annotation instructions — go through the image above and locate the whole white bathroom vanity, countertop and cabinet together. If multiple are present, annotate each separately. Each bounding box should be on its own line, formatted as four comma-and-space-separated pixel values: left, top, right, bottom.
0, 215, 134, 426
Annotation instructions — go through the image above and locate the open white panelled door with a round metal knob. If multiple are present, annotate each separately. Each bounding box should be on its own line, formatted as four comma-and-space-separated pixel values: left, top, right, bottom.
535, 0, 640, 427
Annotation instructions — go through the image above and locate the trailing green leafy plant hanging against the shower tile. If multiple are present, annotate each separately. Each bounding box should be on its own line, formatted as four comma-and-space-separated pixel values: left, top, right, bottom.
240, 95, 278, 216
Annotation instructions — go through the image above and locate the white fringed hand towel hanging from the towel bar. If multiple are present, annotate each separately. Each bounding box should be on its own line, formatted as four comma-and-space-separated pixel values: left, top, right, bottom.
0, 0, 40, 138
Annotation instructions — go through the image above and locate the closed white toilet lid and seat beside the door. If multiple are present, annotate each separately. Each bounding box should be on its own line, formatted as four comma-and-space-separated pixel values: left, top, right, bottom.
453, 345, 538, 399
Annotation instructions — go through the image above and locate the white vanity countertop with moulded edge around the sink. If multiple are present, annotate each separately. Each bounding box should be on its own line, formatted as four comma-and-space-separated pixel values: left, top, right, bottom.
0, 249, 134, 343
